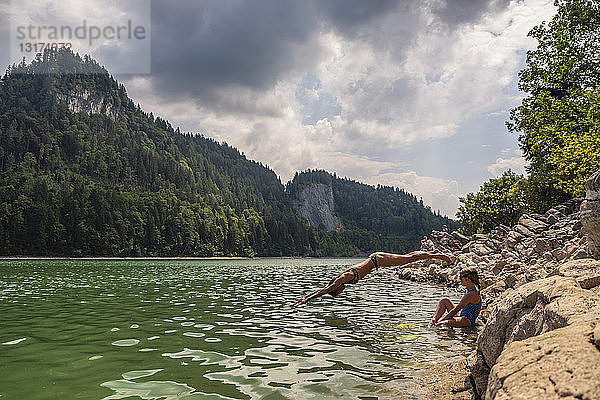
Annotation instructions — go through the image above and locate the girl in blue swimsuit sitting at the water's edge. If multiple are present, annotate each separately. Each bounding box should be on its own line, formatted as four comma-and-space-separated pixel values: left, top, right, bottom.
429, 267, 481, 327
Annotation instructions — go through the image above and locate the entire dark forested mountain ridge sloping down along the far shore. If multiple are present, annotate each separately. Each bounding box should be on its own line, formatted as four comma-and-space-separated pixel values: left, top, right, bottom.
0, 50, 455, 256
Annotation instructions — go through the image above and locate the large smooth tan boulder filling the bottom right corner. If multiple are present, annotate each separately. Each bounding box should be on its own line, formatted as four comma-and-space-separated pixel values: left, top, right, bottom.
485, 309, 600, 400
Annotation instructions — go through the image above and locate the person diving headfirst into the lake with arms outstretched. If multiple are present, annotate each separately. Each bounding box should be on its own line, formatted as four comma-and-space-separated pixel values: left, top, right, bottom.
294, 251, 453, 305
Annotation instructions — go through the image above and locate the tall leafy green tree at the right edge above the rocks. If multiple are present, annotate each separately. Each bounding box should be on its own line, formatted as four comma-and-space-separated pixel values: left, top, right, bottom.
507, 0, 600, 212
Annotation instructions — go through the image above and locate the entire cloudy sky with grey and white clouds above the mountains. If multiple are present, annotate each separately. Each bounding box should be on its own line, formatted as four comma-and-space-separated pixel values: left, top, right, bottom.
0, 0, 555, 216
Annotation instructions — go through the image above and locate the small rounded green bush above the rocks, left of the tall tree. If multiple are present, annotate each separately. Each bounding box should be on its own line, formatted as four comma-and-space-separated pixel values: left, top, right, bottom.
456, 170, 524, 235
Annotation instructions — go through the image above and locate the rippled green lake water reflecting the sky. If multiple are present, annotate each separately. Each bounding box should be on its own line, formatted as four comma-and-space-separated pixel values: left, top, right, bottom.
0, 259, 476, 400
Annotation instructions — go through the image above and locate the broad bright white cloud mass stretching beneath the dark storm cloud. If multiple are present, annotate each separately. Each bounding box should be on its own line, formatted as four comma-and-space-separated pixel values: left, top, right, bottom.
122, 0, 555, 216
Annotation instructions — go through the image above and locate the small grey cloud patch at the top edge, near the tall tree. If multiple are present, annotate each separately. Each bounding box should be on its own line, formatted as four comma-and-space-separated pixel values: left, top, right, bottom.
434, 0, 510, 28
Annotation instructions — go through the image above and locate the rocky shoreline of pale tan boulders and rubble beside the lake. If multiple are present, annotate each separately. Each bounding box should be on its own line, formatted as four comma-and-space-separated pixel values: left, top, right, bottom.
398, 171, 600, 400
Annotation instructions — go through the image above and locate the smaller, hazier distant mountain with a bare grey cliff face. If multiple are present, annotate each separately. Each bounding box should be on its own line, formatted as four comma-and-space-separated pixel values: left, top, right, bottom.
286, 170, 459, 252
